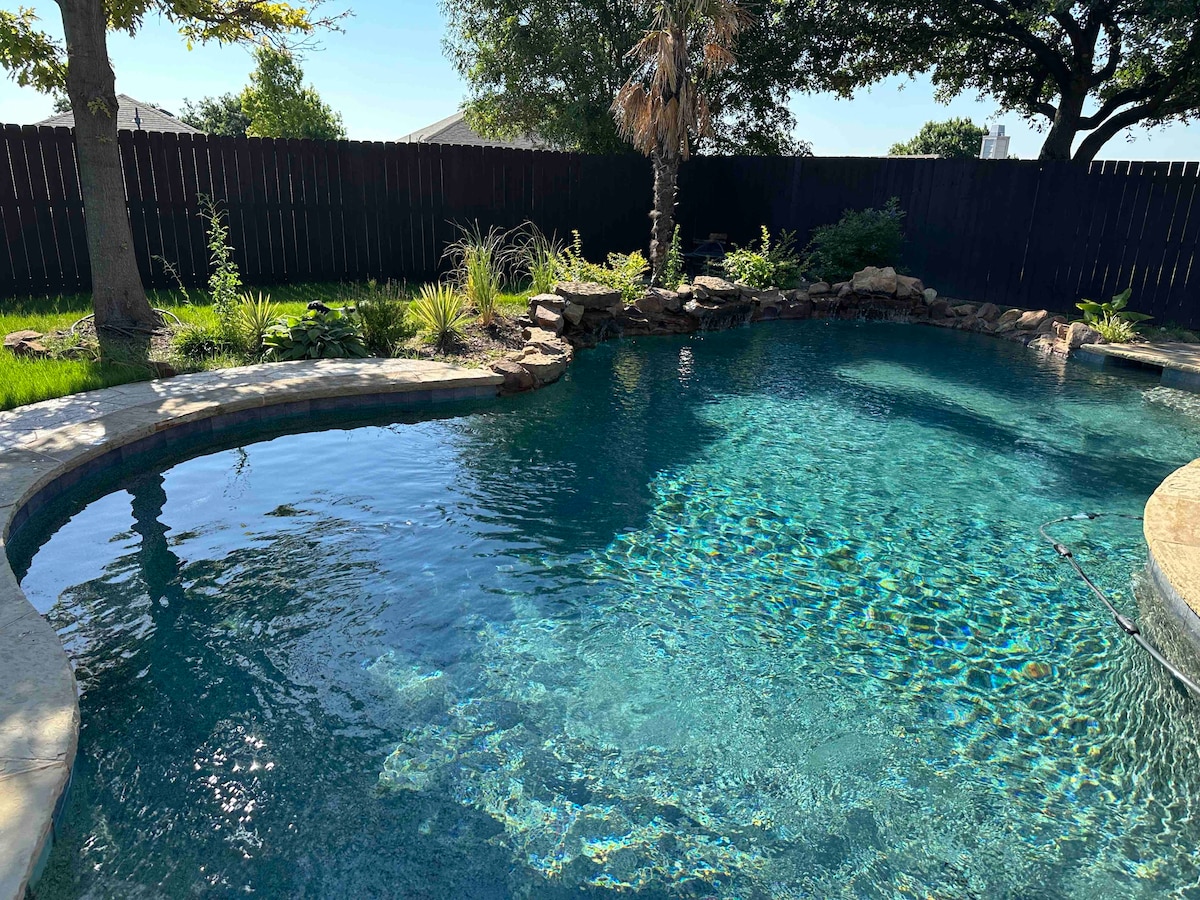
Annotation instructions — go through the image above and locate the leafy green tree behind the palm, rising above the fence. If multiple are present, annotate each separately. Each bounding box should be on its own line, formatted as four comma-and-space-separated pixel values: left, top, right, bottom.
442, 0, 810, 154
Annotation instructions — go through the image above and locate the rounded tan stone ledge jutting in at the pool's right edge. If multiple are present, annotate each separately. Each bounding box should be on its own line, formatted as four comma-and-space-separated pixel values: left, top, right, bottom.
1142, 460, 1200, 636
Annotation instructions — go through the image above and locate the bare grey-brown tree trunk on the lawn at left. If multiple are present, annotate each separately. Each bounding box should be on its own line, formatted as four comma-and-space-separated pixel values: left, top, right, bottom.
58, 0, 158, 350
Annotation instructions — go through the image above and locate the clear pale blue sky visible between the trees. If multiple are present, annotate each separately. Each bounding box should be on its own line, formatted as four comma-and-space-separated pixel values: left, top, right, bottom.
0, 0, 1200, 160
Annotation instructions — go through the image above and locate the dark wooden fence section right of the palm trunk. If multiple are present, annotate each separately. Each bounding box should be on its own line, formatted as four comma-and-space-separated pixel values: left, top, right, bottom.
680, 157, 1200, 328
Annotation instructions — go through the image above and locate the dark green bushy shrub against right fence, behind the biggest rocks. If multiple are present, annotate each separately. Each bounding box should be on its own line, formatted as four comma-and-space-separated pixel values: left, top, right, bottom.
804, 197, 904, 282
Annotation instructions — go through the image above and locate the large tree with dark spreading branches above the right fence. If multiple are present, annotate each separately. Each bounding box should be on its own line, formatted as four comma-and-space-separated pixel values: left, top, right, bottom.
785, 0, 1200, 161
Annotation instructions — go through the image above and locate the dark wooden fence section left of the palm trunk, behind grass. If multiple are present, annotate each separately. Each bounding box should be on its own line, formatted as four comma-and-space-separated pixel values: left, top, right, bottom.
0, 125, 650, 296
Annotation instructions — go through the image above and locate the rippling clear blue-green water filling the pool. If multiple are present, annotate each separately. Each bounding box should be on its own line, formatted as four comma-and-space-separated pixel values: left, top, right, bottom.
16, 323, 1200, 900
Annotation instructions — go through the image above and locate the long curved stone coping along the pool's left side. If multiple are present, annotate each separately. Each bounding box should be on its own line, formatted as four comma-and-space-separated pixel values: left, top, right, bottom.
0, 359, 504, 900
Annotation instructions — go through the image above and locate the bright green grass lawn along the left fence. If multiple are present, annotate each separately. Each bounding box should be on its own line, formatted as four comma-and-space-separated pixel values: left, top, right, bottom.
0, 283, 528, 409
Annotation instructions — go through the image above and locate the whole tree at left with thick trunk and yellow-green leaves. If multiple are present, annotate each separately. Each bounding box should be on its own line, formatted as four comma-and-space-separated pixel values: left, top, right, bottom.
0, 0, 332, 338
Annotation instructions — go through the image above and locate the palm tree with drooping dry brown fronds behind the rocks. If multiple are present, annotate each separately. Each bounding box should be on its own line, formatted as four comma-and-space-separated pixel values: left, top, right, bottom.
612, 0, 750, 283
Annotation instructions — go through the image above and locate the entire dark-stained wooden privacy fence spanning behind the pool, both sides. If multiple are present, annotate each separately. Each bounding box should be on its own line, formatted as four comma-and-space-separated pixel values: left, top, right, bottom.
0, 126, 1200, 328
